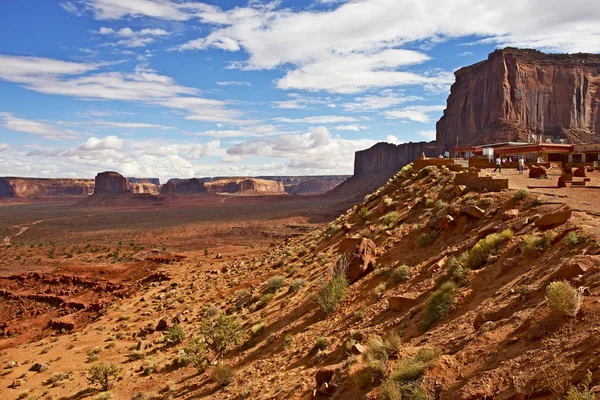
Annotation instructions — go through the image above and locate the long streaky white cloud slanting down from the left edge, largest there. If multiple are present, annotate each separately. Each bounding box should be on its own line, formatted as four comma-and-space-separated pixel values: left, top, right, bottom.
0, 55, 242, 123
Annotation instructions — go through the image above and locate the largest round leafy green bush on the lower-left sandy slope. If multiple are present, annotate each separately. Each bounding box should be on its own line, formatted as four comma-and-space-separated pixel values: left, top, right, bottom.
200, 315, 243, 359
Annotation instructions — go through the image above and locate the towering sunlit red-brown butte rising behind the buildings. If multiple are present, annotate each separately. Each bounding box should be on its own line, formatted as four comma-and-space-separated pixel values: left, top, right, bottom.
436, 48, 600, 153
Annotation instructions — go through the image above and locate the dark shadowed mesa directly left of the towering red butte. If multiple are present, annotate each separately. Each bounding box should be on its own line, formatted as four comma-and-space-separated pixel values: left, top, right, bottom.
354, 142, 436, 177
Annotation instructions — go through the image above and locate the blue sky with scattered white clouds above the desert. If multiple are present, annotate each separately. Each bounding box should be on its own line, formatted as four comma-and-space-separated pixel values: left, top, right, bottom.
0, 0, 600, 181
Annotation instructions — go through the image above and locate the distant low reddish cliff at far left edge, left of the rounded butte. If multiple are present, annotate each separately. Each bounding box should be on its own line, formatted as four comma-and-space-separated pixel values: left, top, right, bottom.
0, 177, 94, 198
